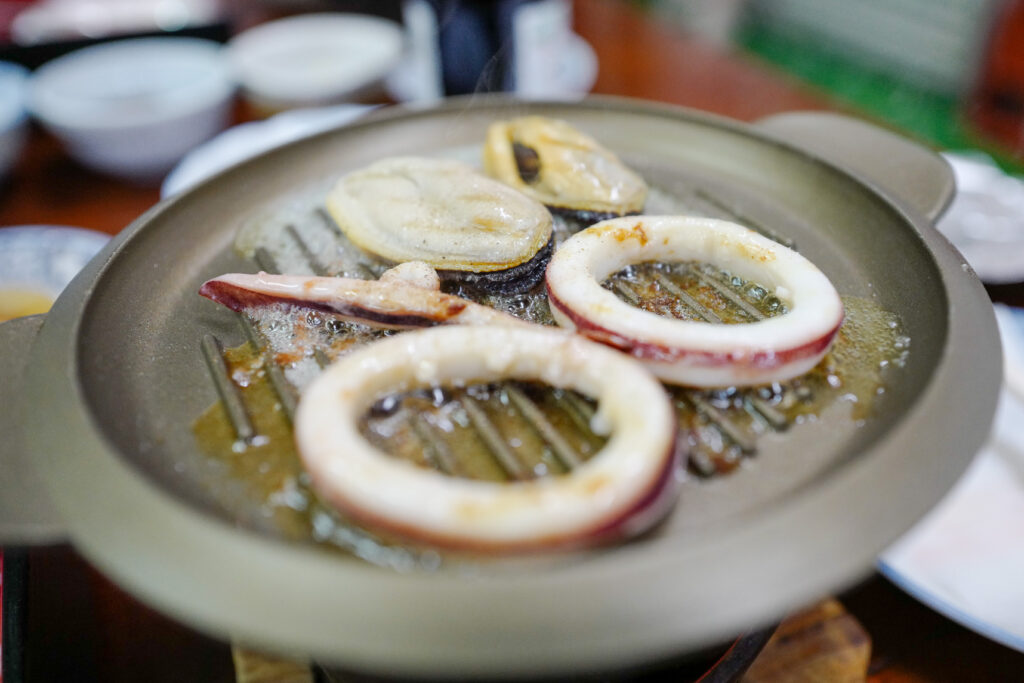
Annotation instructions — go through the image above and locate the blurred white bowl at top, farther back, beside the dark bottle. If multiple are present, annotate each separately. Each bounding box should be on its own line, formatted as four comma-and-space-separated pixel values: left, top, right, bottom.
227, 12, 403, 113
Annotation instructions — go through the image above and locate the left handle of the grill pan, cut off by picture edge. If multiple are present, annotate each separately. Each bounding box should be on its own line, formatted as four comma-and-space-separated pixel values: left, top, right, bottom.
0, 315, 66, 546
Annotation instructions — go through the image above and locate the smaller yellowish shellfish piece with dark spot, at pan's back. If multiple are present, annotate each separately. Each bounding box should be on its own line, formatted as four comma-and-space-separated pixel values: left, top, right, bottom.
483, 116, 647, 224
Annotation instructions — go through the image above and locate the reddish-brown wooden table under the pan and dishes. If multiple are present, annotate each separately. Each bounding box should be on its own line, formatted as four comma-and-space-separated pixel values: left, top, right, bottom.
0, 0, 1024, 683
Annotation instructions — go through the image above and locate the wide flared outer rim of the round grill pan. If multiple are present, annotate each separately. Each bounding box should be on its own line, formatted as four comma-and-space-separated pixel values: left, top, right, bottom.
12, 98, 999, 676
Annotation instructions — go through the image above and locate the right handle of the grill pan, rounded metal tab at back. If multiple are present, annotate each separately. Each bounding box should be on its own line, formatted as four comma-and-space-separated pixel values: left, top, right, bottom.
754, 112, 956, 223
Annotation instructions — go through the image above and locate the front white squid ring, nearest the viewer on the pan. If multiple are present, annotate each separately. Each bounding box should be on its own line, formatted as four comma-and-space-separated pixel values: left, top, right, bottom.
295, 327, 677, 551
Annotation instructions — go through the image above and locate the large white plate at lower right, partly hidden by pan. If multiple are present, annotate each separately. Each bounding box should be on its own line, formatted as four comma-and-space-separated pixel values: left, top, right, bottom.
879, 306, 1024, 652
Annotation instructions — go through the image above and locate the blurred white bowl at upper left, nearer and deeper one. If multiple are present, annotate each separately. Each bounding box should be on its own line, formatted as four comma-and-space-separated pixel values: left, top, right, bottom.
29, 37, 234, 182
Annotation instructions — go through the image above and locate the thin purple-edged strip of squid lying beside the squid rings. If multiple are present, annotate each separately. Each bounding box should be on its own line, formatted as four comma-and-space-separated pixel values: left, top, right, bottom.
200, 263, 528, 330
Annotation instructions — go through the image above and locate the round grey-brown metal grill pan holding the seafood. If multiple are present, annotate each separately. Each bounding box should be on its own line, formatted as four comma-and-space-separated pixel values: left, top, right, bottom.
8, 99, 999, 677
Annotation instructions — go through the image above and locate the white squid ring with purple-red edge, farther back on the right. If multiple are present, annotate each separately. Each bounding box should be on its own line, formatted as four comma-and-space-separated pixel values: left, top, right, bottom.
546, 216, 843, 387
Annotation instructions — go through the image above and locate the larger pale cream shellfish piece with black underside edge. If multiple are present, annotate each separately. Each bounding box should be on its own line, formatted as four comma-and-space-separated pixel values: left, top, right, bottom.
327, 157, 552, 294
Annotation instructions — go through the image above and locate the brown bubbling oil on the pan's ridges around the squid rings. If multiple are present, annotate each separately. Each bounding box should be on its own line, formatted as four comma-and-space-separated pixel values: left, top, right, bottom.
195, 283, 909, 557
